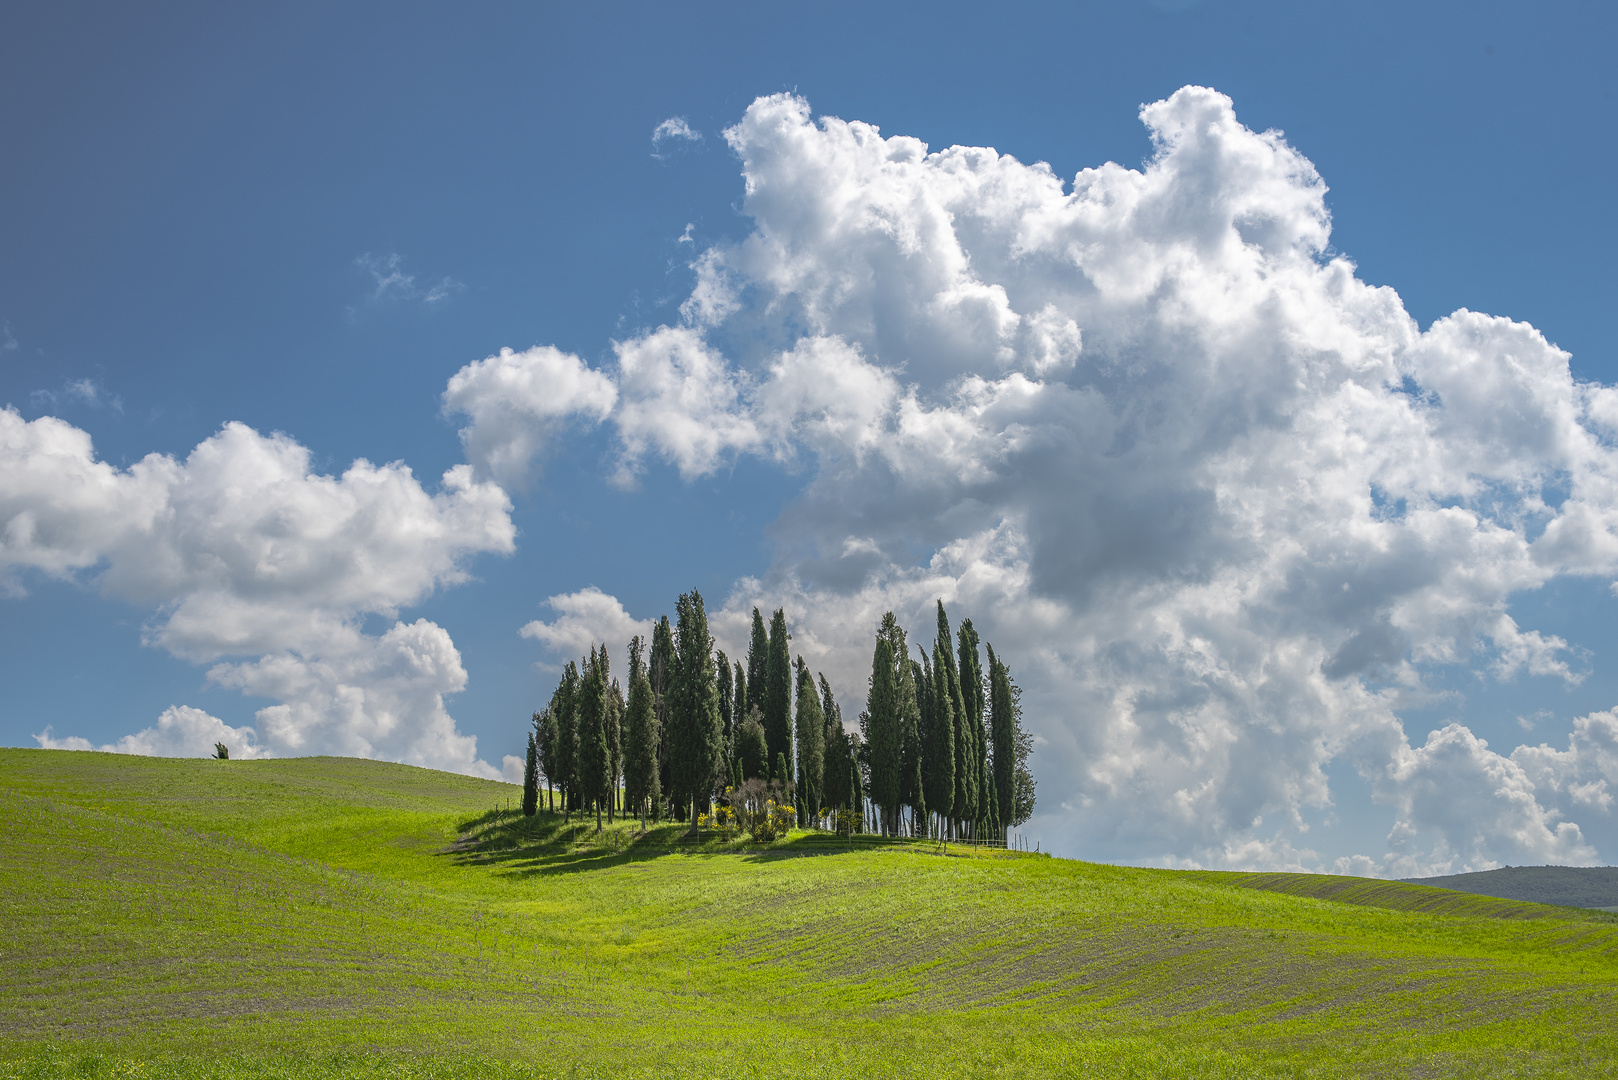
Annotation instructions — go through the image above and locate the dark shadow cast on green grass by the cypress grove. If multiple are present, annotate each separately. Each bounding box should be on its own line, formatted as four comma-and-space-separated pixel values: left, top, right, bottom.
438, 810, 940, 878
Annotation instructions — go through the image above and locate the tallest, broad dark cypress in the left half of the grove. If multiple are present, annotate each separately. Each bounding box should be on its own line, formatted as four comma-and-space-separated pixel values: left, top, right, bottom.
668, 589, 722, 832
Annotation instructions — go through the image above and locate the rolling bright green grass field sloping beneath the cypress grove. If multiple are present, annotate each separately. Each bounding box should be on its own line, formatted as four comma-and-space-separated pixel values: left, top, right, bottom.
0, 750, 1618, 1080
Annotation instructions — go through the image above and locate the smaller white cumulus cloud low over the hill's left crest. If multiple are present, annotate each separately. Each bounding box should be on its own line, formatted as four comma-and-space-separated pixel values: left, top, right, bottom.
0, 410, 513, 776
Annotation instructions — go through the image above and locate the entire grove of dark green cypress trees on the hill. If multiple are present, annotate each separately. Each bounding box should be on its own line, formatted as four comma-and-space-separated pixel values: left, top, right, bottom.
523, 591, 1034, 839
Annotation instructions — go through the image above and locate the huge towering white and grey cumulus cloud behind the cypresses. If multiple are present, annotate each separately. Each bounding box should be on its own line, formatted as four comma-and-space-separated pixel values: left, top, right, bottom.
458, 87, 1618, 873
